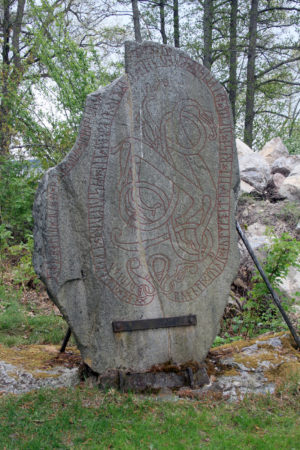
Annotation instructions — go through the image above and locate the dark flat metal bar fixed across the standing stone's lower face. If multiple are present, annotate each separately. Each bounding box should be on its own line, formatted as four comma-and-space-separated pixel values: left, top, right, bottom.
112, 314, 197, 333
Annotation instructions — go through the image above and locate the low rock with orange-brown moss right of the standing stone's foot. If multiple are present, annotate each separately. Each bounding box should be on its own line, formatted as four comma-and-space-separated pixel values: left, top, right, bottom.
191, 333, 300, 401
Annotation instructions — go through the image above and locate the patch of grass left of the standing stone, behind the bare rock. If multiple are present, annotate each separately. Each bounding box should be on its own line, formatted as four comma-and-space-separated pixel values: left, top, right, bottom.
0, 286, 67, 346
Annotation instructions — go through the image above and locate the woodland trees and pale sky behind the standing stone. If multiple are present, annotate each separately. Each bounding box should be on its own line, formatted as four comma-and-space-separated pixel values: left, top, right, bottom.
0, 0, 300, 340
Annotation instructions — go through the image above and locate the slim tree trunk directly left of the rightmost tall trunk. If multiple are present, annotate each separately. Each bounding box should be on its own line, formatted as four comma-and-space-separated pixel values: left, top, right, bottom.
228, 0, 238, 124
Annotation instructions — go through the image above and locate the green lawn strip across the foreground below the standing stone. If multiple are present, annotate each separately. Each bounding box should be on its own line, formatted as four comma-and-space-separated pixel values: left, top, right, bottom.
0, 386, 300, 450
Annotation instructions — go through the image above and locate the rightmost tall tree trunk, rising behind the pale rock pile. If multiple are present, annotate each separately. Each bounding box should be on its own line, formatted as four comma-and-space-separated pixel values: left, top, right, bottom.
244, 0, 259, 147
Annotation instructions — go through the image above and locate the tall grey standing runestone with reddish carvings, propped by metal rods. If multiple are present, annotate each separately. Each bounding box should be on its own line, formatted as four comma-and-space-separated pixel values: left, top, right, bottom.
34, 42, 239, 374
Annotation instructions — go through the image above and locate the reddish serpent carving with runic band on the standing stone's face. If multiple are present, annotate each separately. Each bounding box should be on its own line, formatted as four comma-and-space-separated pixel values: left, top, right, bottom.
89, 46, 233, 306
